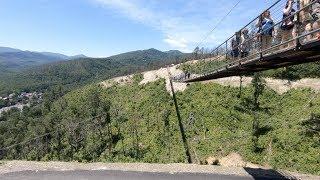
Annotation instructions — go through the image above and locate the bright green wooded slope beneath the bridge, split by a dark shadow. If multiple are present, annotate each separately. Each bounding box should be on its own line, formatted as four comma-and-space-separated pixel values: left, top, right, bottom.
0, 74, 320, 175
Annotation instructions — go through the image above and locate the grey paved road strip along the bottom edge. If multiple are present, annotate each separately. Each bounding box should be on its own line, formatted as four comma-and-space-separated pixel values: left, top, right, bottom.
0, 170, 283, 180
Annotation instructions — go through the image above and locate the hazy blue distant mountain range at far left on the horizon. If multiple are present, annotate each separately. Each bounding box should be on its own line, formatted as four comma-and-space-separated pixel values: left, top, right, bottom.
0, 47, 86, 72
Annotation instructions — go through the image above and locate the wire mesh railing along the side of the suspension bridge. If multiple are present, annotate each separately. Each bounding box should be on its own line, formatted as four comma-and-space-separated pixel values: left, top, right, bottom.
173, 0, 320, 81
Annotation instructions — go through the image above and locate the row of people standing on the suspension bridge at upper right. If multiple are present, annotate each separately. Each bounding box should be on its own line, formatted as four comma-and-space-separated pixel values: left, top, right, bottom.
230, 0, 320, 60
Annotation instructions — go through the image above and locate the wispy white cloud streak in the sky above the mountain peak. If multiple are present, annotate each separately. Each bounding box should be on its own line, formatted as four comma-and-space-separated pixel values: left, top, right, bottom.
95, 0, 221, 51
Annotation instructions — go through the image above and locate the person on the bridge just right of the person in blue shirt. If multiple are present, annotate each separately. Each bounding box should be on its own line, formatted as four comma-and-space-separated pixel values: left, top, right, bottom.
280, 0, 296, 49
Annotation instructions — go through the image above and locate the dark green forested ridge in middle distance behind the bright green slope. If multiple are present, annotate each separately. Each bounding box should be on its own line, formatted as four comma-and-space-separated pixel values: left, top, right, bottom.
0, 49, 187, 96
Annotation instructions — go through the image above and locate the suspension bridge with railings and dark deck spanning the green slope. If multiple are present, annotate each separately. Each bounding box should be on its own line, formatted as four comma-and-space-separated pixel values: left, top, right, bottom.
172, 0, 320, 83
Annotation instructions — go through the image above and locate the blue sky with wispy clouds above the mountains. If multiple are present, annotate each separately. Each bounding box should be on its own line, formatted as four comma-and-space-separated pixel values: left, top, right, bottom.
0, 0, 276, 57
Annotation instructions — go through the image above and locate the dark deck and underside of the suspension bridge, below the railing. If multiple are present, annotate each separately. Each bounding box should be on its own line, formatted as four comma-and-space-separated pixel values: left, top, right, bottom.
175, 40, 320, 82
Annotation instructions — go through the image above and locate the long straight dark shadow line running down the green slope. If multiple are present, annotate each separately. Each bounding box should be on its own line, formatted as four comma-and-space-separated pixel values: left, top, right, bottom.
170, 78, 192, 164
